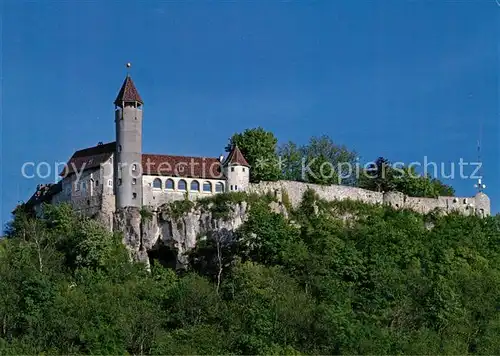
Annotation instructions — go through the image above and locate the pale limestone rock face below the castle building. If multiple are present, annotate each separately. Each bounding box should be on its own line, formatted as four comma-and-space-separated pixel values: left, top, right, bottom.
114, 202, 248, 268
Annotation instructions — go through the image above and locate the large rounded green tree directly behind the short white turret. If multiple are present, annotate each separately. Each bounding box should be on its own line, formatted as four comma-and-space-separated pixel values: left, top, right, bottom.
226, 127, 281, 182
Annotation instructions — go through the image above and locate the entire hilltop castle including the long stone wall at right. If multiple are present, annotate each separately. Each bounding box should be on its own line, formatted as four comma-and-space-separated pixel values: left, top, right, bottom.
26, 75, 490, 226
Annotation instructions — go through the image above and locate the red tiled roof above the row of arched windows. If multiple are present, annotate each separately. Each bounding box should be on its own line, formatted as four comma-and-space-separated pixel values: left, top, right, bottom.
142, 154, 224, 179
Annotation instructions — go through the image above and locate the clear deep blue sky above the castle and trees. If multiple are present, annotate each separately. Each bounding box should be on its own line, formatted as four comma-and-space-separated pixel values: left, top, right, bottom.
0, 0, 500, 225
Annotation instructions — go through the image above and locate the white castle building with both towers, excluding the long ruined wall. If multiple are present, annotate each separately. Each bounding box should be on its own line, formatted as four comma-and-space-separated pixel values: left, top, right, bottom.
24, 75, 250, 221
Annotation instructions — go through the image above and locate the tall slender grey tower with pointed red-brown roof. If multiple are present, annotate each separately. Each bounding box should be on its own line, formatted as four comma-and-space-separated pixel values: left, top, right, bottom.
114, 75, 143, 209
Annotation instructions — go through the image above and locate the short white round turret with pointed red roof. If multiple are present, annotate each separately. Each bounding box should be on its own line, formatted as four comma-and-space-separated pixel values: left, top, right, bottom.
222, 145, 250, 192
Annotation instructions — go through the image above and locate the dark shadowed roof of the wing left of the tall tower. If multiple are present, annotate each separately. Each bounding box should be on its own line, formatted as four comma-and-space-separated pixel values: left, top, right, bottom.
59, 142, 116, 176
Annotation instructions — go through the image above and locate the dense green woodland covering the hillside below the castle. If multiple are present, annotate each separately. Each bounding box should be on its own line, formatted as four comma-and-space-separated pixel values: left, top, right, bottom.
0, 190, 500, 355
